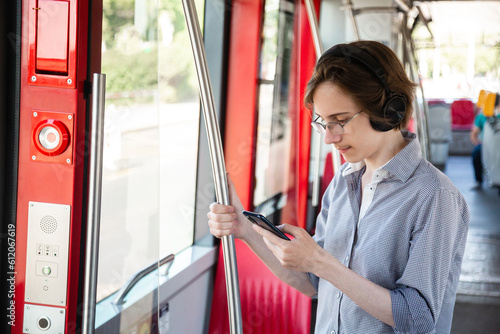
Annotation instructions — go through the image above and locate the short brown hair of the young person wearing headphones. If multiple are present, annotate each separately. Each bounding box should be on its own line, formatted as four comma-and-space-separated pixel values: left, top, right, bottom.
304, 41, 416, 129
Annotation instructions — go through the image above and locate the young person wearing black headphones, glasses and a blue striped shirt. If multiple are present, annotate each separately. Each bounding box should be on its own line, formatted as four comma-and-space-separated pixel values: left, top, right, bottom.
208, 41, 469, 333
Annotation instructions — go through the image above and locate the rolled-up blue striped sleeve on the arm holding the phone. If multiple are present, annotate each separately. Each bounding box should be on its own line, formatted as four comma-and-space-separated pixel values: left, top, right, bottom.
390, 188, 469, 333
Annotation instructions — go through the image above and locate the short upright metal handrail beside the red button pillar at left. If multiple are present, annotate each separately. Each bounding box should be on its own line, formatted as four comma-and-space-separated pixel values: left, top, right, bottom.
82, 73, 106, 334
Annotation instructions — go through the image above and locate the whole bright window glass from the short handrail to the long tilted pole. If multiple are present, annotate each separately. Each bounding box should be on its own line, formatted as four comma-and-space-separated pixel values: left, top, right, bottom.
97, 0, 204, 301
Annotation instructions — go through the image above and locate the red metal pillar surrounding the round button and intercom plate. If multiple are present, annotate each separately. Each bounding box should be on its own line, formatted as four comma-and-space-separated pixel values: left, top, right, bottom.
12, 0, 91, 334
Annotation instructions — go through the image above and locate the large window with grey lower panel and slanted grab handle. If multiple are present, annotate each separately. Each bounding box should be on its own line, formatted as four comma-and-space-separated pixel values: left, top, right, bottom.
96, 0, 213, 334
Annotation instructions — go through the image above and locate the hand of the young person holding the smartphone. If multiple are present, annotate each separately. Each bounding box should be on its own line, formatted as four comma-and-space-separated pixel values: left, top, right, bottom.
253, 224, 330, 273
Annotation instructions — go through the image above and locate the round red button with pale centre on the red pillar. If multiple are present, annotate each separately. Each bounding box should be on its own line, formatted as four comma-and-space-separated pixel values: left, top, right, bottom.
33, 119, 70, 156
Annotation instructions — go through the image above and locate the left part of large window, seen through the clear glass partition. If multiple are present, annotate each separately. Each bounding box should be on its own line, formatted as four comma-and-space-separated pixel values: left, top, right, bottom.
97, 0, 159, 301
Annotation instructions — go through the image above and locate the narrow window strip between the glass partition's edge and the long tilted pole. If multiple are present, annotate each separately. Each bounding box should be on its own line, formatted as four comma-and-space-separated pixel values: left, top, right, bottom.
158, 0, 204, 257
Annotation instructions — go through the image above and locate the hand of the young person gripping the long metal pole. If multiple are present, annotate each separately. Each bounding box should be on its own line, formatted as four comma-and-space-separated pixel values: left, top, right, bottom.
207, 174, 251, 239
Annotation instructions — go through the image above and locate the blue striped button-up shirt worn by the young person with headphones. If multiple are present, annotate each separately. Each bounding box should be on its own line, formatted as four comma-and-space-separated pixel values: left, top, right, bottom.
309, 132, 469, 334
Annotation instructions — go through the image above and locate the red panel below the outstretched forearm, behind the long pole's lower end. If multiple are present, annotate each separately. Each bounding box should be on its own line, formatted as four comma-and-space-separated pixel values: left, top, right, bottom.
209, 240, 311, 334
